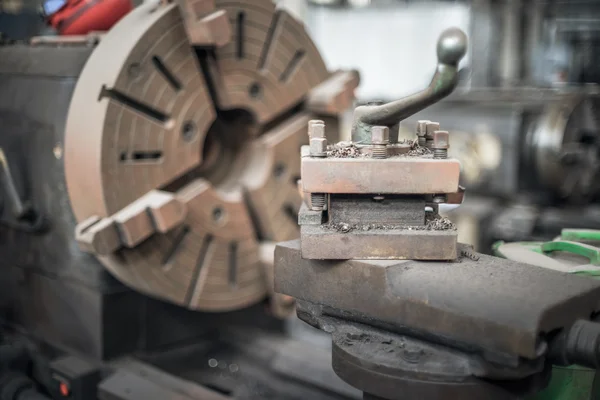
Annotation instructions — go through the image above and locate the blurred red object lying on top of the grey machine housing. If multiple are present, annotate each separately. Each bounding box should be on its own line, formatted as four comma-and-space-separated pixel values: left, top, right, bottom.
48, 0, 133, 35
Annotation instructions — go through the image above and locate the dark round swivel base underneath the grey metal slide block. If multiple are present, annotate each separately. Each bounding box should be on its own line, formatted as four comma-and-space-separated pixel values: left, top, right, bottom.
328, 317, 549, 400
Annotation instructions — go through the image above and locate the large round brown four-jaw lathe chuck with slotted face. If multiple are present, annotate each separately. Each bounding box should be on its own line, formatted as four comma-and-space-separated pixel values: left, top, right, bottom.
64, 0, 330, 311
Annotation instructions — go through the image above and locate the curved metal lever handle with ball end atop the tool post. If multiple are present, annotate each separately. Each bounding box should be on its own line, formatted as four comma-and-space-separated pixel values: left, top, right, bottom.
352, 28, 467, 143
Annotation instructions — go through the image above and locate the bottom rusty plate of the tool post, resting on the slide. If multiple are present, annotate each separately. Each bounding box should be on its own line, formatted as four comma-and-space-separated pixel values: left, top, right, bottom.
300, 225, 458, 260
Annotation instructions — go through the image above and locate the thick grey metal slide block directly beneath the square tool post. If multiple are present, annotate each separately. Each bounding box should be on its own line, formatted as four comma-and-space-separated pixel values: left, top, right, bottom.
275, 241, 600, 359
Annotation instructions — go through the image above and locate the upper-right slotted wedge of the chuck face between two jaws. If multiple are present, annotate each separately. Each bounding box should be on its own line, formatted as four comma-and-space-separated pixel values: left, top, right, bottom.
216, 0, 329, 124
